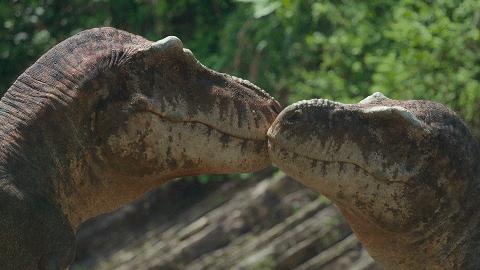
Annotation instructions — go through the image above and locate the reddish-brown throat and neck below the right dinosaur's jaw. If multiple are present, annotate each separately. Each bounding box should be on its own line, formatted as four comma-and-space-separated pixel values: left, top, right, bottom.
339, 173, 480, 270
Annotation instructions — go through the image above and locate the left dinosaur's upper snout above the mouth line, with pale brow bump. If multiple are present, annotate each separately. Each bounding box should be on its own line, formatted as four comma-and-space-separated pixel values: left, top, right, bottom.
128, 37, 281, 140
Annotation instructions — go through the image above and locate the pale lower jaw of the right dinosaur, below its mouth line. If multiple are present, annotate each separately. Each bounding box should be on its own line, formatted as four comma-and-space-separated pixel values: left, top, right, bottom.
268, 139, 409, 231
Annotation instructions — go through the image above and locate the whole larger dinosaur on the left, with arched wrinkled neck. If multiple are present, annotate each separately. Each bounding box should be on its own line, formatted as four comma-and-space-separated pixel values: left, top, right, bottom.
0, 28, 280, 270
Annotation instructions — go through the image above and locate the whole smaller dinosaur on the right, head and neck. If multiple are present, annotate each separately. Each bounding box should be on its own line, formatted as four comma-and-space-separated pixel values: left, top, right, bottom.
268, 93, 480, 269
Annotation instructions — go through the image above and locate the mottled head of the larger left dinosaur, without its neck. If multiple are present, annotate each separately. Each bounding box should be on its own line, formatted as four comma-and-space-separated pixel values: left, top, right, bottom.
91, 34, 280, 184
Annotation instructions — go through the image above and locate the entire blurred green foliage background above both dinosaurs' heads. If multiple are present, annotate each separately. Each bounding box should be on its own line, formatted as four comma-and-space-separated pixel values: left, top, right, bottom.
0, 0, 480, 137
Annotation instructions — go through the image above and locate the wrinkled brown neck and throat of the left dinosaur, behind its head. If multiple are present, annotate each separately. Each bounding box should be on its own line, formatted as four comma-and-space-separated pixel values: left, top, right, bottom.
0, 28, 162, 229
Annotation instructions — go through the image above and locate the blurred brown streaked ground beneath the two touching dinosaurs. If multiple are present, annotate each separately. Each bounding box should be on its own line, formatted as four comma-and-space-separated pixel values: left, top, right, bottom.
71, 170, 381, 270
